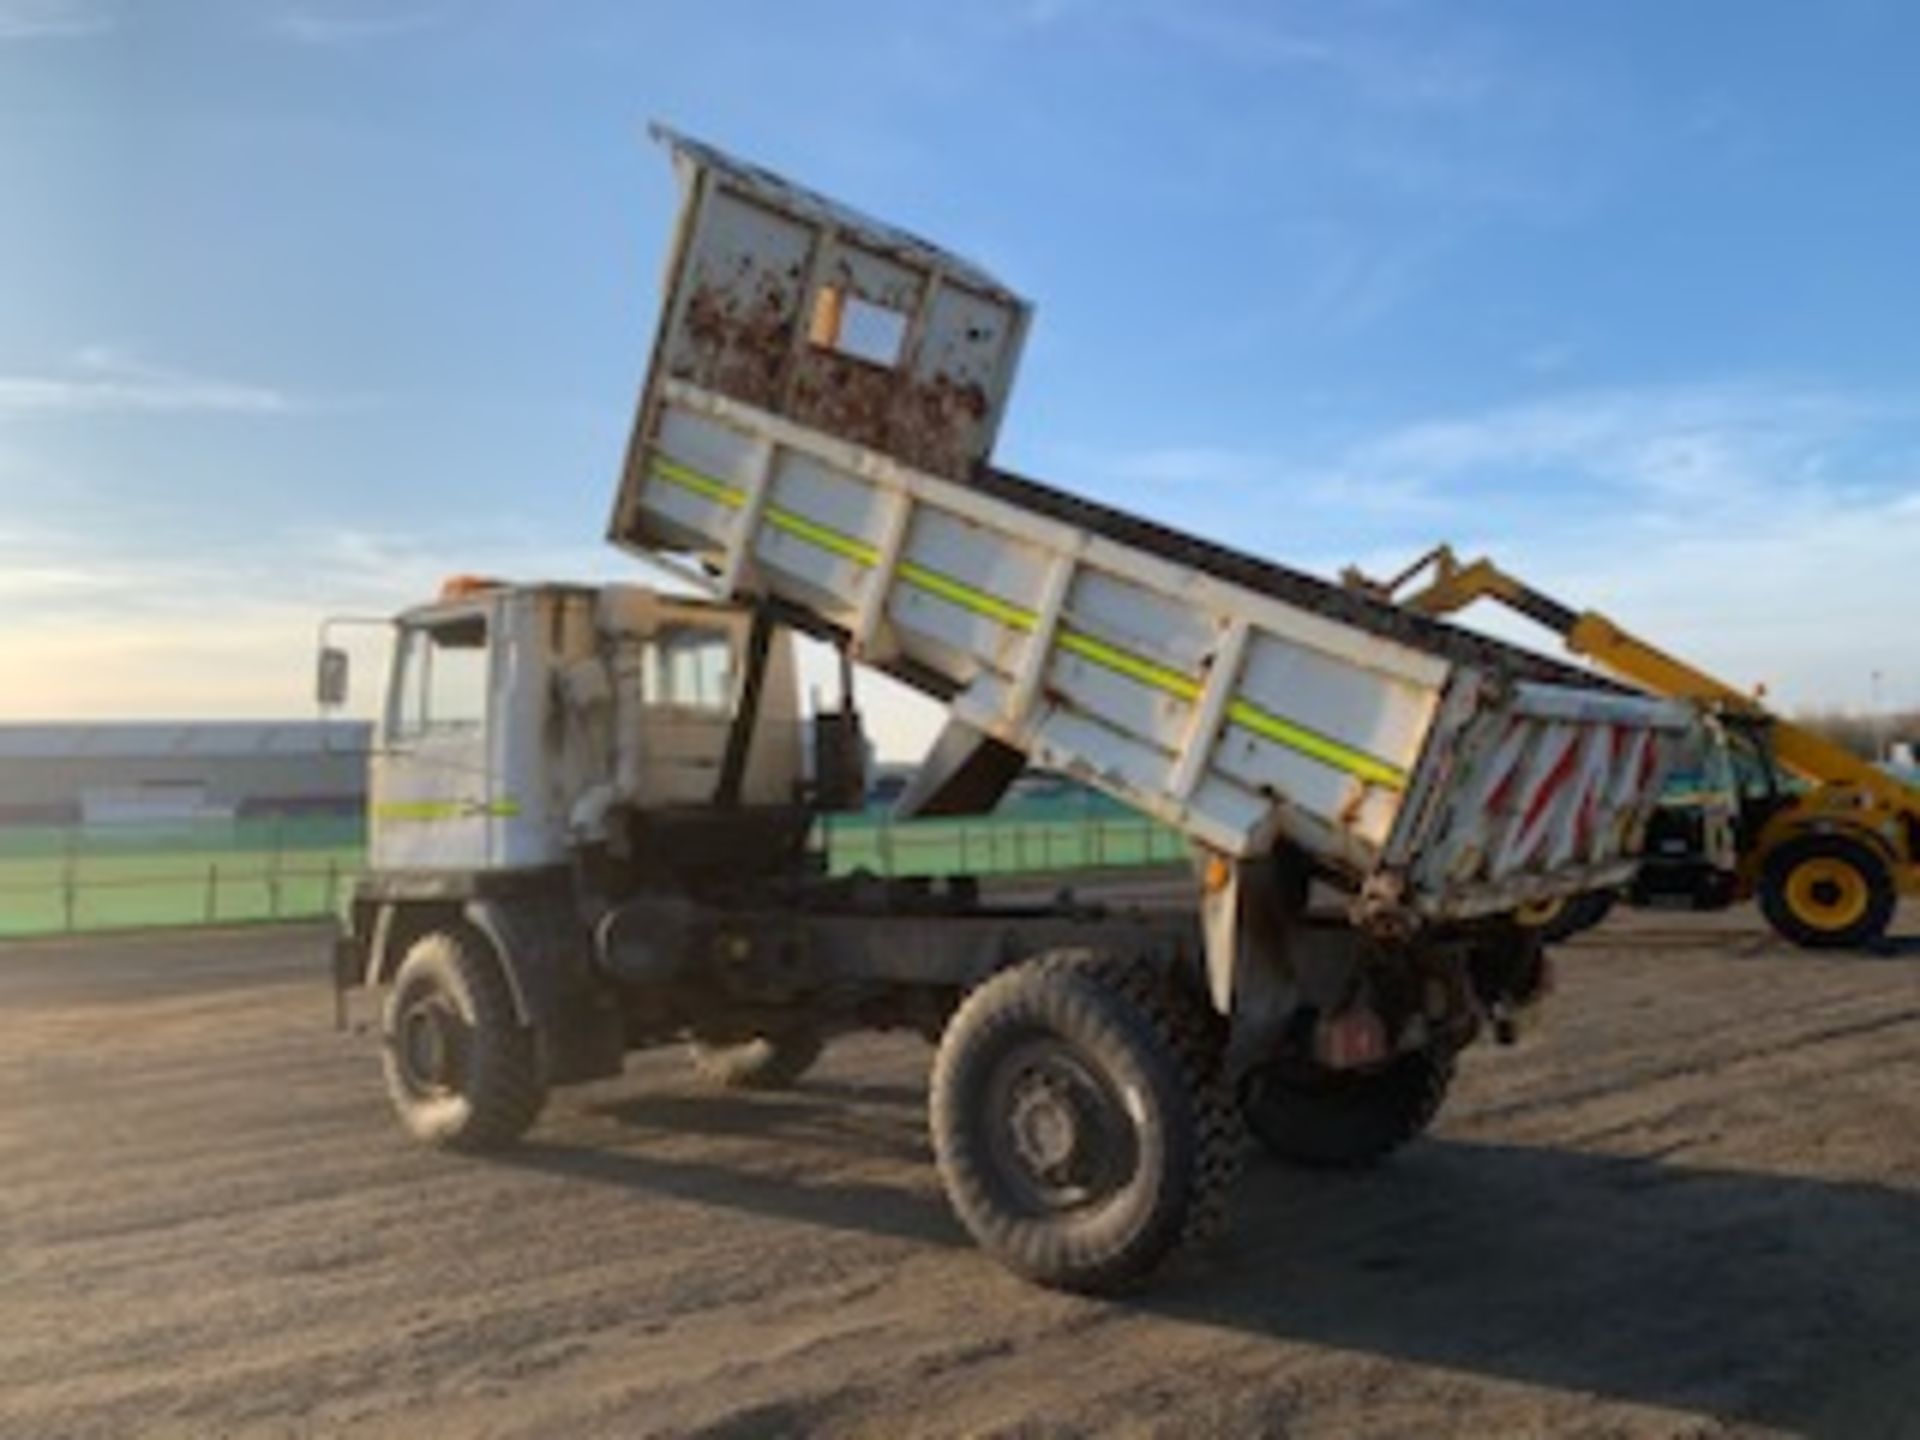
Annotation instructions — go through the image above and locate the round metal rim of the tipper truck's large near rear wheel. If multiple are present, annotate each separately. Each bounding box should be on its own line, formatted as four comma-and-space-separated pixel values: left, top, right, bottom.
983, 1037, 1139, 1217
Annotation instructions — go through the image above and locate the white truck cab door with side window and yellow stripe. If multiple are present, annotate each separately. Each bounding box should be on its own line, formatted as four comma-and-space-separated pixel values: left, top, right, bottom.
371, 605, 503, 870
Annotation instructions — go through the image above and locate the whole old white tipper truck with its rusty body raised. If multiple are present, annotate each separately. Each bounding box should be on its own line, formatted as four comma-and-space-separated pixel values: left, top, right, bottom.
334, 131, 1690, 1290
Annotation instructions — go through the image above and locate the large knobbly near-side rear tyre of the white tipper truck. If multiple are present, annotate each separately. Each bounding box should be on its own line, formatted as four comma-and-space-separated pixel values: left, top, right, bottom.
929, 950, 1244, 1294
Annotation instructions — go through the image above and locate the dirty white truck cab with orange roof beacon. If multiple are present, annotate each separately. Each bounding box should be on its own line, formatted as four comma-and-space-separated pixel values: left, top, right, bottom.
369, 578, 803, 876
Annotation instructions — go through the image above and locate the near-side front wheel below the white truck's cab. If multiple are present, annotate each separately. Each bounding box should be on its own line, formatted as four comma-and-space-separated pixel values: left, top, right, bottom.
380, 929, 547, 1152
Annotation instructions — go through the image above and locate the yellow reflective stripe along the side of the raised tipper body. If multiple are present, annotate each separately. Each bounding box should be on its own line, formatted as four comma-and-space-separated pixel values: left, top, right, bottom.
653, 455, 1407, 789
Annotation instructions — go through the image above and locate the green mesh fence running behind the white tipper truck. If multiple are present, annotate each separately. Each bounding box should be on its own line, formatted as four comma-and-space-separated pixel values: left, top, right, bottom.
0, 793, 1187, 939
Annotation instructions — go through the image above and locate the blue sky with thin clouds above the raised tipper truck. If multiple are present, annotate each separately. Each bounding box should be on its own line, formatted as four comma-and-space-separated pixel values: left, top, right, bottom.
0, 0, 1920, 751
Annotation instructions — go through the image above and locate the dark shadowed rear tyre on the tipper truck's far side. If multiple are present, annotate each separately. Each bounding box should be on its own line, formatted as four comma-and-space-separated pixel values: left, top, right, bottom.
1240, 1046, 1455, 1169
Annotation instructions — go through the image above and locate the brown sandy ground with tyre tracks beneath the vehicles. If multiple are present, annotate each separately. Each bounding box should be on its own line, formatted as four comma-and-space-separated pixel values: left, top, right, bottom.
0, 914, 1920, 1438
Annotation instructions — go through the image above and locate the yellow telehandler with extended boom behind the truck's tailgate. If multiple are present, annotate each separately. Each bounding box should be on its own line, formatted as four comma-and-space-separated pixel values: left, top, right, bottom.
1344, 545, 1920, 948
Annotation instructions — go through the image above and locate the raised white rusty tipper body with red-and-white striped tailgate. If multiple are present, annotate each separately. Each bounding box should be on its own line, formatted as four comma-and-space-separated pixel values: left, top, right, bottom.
612, 136, 1686, 918
